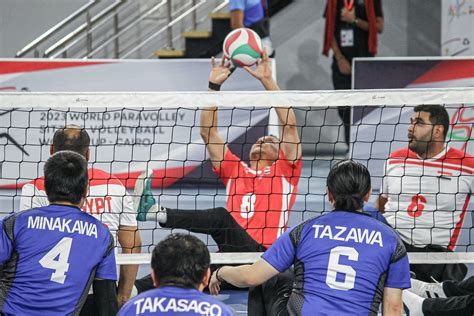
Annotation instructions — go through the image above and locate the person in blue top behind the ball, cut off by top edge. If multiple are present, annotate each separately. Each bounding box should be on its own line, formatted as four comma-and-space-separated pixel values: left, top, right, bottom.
229, 0, 275, 58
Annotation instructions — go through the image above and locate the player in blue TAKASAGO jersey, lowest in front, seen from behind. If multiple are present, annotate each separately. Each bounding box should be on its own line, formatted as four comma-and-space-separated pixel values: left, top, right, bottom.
119, 234, 233, 316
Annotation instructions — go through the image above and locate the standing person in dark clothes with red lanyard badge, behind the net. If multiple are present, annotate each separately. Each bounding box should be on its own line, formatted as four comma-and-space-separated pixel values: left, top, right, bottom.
323, 0, 384, 145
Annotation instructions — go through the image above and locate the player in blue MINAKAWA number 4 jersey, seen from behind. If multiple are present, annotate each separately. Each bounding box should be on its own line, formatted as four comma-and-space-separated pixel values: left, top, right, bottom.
0, 151, 118, 315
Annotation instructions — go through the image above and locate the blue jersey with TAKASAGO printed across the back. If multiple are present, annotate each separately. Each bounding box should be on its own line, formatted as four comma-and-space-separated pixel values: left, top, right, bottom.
119, 286, 233, 316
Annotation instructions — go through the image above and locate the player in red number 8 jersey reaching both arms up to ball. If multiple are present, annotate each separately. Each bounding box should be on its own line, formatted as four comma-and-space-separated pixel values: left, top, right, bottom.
134, 52, 302, 314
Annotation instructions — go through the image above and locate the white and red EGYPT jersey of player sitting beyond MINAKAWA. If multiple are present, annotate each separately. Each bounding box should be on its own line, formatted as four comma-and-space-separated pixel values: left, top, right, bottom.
20, 168, 137, 242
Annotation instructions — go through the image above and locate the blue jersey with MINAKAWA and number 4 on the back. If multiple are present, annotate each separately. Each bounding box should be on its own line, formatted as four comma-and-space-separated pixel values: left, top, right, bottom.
0, 205, 117, 315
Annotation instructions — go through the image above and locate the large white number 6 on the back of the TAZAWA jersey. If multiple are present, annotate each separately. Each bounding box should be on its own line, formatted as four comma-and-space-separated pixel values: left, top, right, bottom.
326, 246, 359, 291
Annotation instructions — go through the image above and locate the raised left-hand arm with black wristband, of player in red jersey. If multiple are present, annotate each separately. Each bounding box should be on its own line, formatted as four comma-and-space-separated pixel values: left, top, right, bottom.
200, 57, 231, 168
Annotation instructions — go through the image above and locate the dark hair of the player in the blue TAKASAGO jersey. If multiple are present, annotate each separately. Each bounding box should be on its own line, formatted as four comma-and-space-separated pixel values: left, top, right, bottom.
151, 234, 211, 288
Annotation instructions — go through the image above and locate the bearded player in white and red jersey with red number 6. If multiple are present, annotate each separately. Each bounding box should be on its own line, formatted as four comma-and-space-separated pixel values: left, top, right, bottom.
376, 105, 474, 282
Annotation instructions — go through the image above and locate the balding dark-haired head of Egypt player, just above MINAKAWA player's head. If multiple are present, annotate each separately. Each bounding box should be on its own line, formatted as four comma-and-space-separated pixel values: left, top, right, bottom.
53, 125, 90, 157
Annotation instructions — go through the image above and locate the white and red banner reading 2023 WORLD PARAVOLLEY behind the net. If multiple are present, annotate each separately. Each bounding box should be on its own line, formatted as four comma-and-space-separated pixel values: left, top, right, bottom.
0, 59, 269, 188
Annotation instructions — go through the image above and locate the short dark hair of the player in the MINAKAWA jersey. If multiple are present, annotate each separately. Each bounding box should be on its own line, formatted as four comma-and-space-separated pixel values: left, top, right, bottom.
44, 150, 89, 204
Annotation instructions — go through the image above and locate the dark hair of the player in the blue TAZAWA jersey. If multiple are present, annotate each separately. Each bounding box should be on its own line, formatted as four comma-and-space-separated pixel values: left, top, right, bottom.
327, 160, 371, 211
